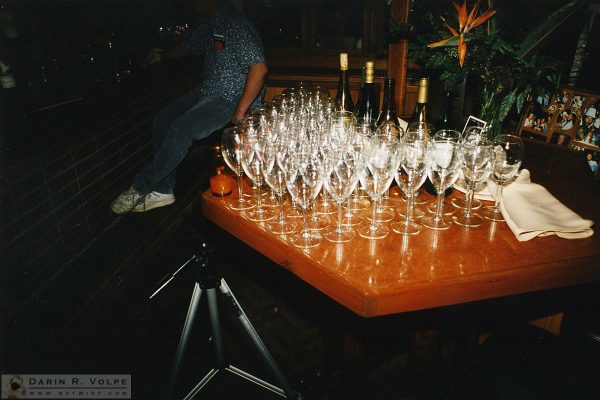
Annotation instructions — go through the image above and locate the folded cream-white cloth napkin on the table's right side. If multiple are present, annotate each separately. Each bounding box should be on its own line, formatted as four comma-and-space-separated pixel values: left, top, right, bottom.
488, 169, 594, 242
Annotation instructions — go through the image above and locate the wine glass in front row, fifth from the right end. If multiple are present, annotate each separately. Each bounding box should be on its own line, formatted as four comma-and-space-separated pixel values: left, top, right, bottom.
358, 135, 399, 239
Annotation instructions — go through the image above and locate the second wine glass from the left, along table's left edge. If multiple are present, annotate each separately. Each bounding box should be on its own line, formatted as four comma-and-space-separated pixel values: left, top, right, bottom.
242, 130, 275, 222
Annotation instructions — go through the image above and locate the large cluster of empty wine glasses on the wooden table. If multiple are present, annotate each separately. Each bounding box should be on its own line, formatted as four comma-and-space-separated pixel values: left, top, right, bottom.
222, 84, 523, 248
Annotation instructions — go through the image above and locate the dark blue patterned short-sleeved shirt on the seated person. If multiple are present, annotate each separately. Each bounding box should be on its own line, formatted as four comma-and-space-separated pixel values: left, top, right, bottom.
187, 4, 265, 108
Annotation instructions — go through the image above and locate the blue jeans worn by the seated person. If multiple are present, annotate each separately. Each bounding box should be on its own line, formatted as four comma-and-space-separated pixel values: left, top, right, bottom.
133, 89, 236, 194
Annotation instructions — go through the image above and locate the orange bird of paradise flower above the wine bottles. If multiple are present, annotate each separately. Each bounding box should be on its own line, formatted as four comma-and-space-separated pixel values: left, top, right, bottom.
427, 0, 496, 68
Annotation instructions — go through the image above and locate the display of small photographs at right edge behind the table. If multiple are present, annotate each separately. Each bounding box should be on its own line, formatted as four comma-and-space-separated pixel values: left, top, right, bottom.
517, 87, 600, 176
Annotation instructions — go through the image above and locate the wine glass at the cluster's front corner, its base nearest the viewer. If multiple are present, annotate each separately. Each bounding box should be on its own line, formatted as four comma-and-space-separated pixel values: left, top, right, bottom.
283, 152, 323, 249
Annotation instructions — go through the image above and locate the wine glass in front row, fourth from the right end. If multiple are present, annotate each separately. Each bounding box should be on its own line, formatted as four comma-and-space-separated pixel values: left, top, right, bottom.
391, 130, 432, 235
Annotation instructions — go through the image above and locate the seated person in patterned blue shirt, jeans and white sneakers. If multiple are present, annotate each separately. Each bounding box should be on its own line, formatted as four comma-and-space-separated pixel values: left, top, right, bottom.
111, 0, 267, 214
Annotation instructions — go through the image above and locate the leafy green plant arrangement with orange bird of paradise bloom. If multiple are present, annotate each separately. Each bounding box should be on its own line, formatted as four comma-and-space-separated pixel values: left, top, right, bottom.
391, 0, 582, 136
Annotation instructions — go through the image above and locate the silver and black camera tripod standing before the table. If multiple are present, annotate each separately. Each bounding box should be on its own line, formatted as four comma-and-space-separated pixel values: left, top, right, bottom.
150, 243, 302, 400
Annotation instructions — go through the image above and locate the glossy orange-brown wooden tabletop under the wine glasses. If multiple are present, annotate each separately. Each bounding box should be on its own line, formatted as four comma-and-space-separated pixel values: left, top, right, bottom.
202, 143, 600, 317
